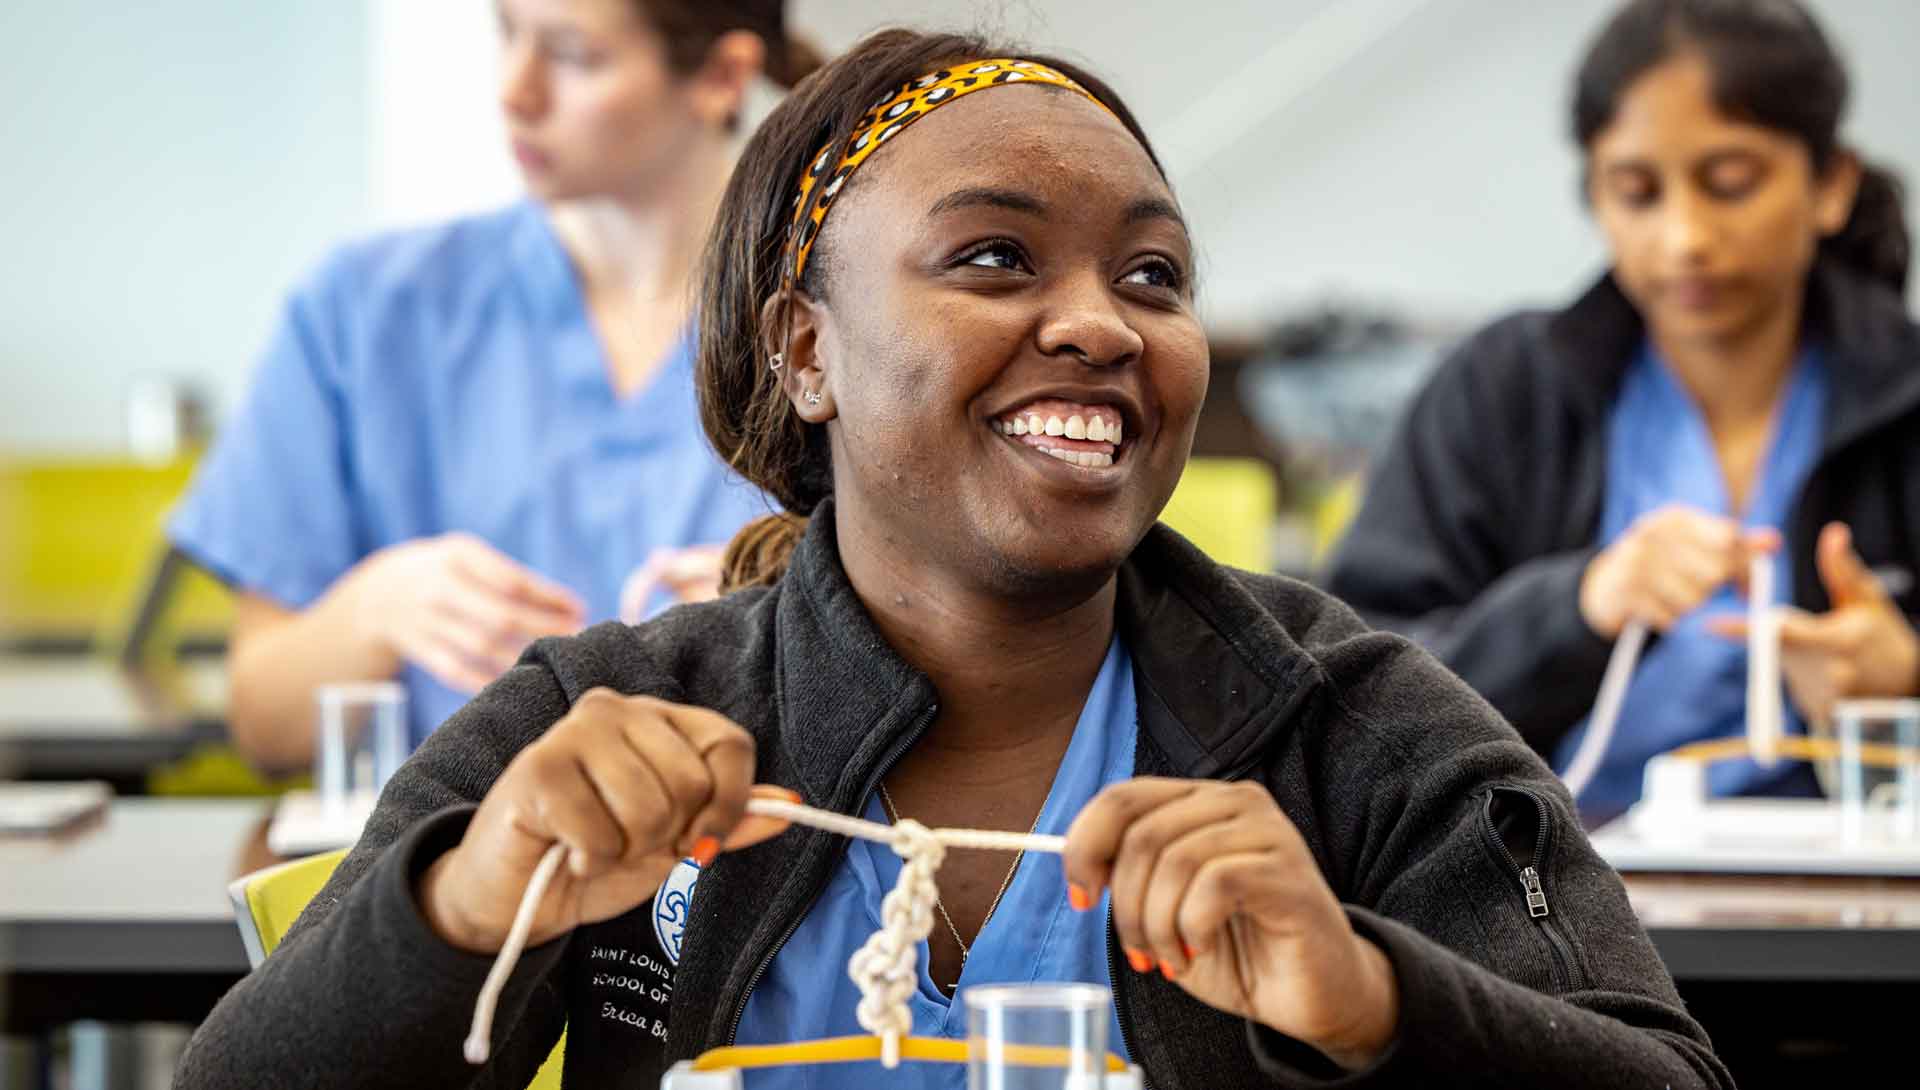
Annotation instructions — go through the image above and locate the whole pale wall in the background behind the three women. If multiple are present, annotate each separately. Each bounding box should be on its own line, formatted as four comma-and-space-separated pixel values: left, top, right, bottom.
0, 0, 1920, 449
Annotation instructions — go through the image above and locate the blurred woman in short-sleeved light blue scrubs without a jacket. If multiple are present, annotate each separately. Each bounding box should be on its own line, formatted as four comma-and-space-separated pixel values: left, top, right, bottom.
169, 0, 816, 768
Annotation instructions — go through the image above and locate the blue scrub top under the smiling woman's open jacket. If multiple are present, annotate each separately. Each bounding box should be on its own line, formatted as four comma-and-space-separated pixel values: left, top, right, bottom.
737, 639, 1139, 1090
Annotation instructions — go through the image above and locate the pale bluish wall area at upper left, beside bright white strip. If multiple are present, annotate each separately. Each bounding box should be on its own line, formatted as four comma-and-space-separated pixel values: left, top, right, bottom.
0, 0, 369, 451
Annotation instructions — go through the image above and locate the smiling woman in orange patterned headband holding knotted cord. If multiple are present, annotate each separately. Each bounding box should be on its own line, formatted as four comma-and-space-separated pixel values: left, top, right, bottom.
180, 31, 1728, 1090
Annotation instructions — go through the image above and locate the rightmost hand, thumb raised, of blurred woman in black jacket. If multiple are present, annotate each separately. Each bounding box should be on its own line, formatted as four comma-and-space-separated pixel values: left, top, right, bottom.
1713, 522, 1920, 727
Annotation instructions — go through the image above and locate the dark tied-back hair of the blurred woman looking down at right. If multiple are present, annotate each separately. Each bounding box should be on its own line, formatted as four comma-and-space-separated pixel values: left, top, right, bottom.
1572, 0, 1912, 292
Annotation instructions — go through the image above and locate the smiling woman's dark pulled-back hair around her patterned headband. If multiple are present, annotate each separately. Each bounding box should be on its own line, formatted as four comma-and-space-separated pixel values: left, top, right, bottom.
693, 31, 1165, 589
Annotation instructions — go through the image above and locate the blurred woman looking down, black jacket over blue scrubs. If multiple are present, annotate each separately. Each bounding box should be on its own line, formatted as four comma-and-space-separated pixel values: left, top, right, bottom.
1331, 0, 1920, 810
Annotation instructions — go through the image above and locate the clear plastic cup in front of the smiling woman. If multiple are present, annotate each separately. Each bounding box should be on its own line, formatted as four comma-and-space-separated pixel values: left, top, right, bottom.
962, 984, 1114, 1090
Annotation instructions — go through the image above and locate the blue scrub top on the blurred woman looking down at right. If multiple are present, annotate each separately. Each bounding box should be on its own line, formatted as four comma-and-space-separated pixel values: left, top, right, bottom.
1553, 344, 1828, 810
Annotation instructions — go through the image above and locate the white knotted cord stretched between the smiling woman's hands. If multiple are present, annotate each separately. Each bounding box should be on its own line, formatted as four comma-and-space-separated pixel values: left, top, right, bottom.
465, 798, 1068, 1067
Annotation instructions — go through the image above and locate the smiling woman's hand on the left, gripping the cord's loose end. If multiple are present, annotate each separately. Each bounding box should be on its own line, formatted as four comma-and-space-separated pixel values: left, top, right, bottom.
419, 689, 799, 954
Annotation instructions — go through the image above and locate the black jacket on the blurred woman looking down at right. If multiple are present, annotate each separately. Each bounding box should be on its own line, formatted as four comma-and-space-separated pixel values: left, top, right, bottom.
1329, 261, 1920, 754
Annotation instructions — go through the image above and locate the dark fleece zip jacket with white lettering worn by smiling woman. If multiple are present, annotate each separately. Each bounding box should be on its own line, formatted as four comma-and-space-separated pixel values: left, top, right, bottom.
179, 505, 1730, 1090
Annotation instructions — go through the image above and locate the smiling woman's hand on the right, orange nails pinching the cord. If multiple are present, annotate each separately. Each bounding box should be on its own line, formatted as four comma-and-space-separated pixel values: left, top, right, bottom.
1066, 779, 1400, 1069
